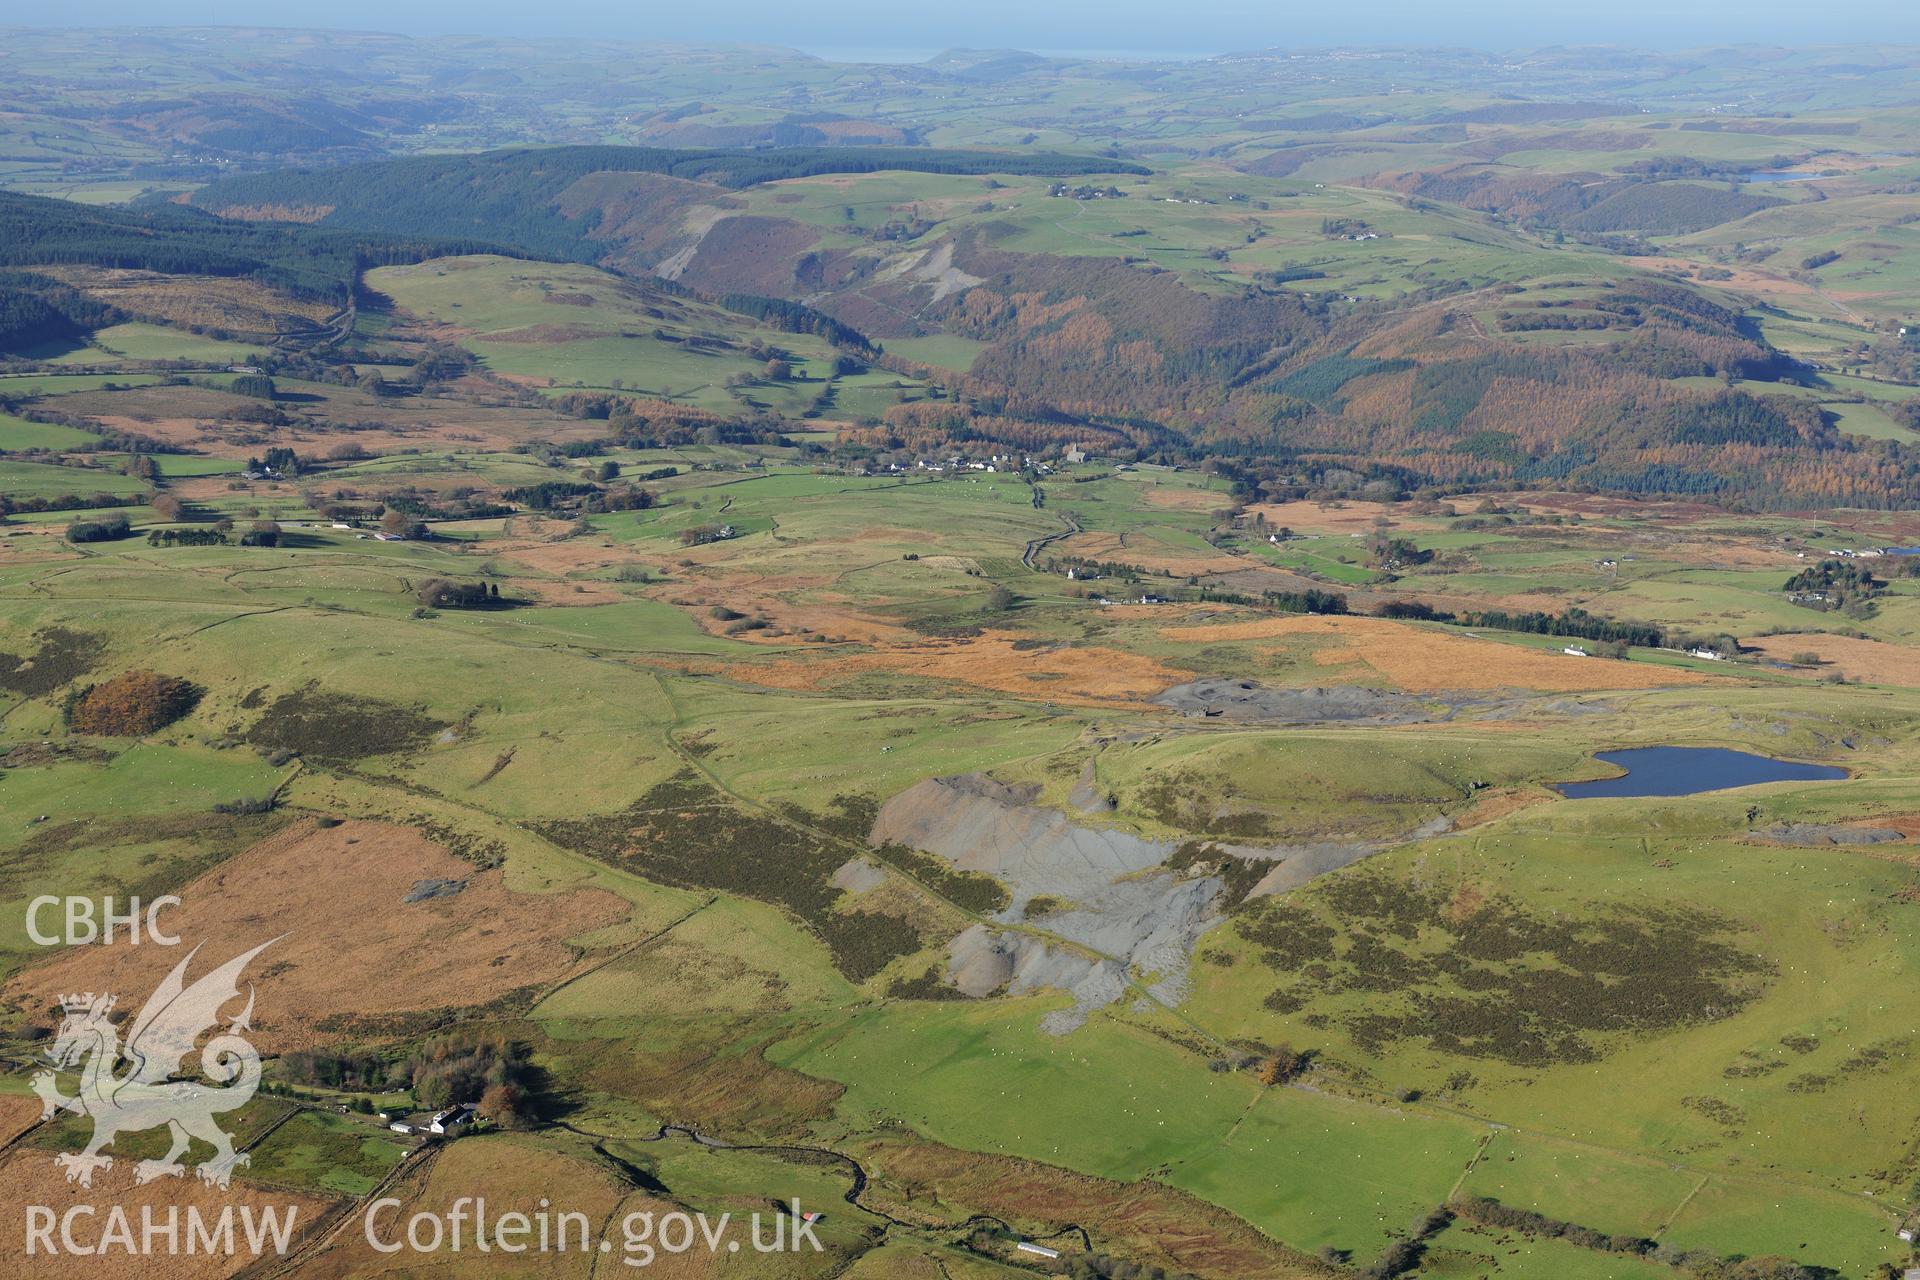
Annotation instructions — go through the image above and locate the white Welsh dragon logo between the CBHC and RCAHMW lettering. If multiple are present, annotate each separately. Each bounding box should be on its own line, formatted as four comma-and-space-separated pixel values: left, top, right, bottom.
33, 938, 278, 1188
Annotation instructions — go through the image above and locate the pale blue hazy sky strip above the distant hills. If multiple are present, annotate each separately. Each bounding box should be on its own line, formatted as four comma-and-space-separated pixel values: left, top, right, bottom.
26, 0, 1920, 56
